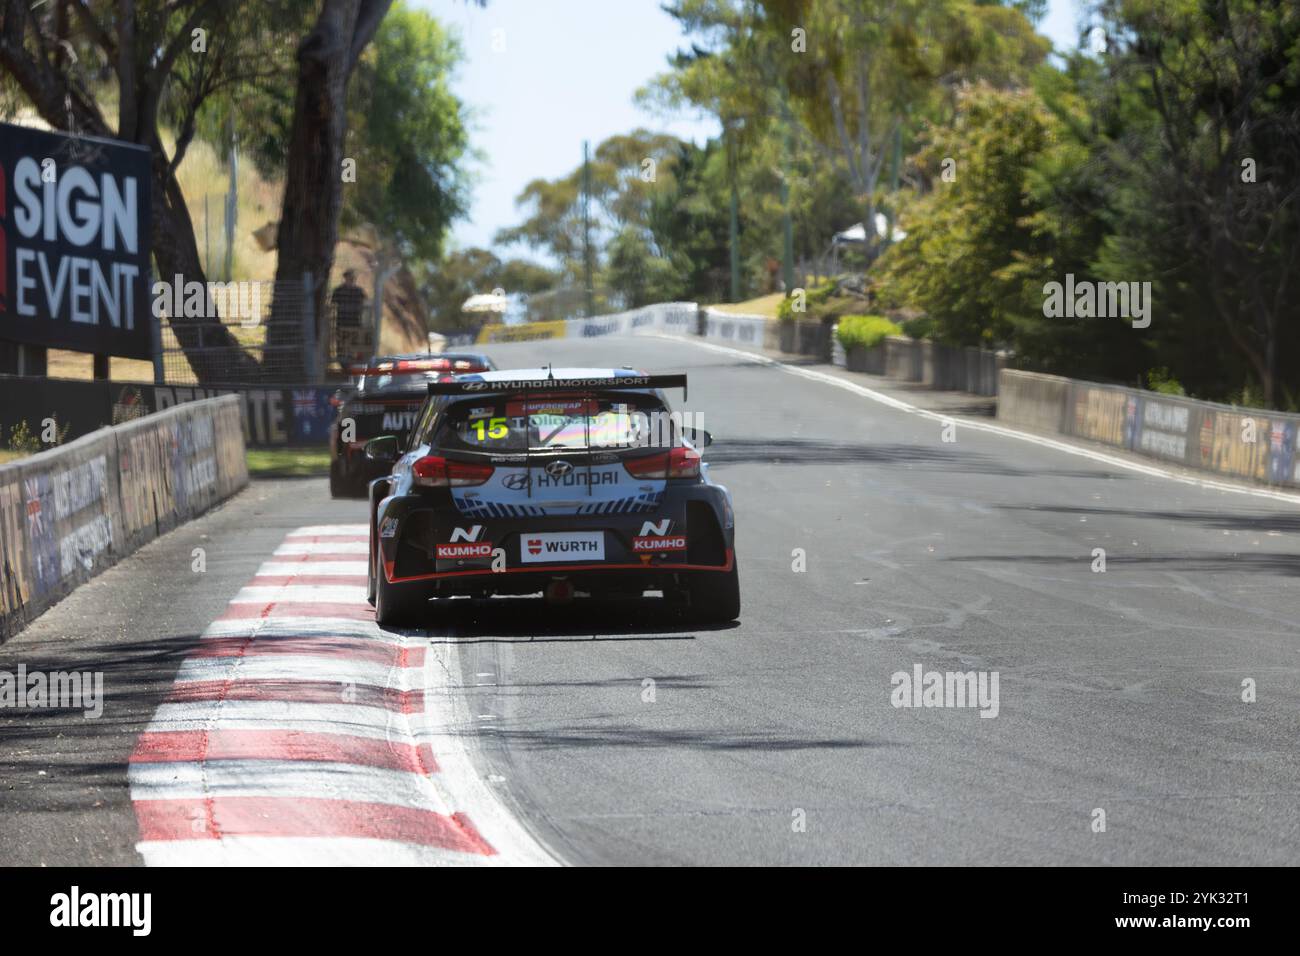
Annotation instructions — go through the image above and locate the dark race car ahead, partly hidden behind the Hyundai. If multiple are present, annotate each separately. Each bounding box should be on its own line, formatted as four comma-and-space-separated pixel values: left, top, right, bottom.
329, 352, 497, 498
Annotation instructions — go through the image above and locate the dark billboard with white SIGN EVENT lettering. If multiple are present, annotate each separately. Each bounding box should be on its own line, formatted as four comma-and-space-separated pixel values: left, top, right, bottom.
0, 124, 153, 359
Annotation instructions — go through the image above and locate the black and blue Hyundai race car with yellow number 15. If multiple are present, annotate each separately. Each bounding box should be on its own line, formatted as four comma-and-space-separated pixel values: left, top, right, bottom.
367, 369, 740, 627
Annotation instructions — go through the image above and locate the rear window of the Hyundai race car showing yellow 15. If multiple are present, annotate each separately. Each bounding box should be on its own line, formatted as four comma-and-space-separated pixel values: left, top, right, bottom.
438, 395, 676, 451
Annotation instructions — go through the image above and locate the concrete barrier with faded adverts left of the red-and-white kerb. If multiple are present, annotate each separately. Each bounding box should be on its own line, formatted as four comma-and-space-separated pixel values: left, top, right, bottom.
0, 395, 248, 643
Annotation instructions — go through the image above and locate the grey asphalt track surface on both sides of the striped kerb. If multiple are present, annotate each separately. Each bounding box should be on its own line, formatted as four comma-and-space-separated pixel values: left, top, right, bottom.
0, 338, 1300, 865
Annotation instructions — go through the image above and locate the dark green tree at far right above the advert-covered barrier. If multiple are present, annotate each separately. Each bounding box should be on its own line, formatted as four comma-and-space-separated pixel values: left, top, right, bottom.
1091, 0, 1300, 407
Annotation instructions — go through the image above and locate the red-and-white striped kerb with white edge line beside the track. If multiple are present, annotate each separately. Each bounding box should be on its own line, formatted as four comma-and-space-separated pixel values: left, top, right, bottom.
130, 525, 555, 865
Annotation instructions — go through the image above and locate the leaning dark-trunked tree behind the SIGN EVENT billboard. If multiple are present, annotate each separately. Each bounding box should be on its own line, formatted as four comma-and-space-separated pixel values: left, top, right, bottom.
0, 0, 294, 382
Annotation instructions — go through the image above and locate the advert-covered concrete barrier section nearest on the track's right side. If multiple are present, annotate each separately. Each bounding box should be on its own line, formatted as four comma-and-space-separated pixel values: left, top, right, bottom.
997, 369, 1300, 488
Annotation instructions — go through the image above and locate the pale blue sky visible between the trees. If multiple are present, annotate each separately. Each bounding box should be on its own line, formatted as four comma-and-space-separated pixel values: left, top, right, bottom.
423, 0, 1078, 259
